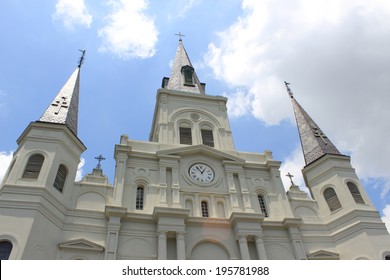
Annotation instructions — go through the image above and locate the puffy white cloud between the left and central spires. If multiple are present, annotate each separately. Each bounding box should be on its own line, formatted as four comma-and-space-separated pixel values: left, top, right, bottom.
98, 0, 158, 59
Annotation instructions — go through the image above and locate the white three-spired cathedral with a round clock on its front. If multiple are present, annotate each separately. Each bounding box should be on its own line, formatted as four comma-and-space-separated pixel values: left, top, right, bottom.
0, 40, 390, 260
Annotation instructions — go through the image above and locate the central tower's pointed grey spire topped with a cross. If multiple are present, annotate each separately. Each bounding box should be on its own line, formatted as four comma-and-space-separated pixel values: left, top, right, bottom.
166, 37, 205, 94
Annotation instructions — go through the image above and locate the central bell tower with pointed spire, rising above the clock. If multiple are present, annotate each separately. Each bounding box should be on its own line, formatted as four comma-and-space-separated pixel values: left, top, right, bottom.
149, 39, 234, 150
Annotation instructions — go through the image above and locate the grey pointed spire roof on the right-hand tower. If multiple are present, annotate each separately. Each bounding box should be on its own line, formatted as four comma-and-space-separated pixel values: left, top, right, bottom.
284, 82, 342, 165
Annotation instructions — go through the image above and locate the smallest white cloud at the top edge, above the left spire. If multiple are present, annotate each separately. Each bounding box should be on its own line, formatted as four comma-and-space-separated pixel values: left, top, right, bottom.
53, 0, 92, 29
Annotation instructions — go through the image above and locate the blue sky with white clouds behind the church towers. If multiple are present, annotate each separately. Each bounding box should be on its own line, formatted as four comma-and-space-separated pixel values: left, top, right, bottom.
0, 0, 390, 232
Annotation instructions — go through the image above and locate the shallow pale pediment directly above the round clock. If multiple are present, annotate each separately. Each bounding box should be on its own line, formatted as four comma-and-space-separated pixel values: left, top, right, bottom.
157, 144, 245, 164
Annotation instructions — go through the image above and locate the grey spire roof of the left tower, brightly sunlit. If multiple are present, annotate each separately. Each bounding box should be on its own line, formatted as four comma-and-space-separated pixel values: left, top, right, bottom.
39, 66, 80, 135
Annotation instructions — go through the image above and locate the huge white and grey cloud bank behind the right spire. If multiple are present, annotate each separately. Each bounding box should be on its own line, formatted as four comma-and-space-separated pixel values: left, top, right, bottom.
204, 0, 390, 201
